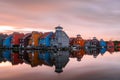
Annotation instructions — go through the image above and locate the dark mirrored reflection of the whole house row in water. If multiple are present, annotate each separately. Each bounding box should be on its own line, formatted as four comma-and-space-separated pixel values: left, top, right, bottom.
0, 47, 118, 73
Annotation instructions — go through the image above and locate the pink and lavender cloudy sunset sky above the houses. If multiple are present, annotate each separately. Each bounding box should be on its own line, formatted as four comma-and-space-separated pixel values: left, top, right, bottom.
0, 0, 120, 40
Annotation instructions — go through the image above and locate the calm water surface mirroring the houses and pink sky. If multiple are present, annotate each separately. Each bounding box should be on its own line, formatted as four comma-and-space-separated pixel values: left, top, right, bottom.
0, 50, 120, 80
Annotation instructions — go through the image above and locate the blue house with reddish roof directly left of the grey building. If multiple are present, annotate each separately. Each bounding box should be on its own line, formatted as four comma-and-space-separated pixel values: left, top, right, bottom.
39, 32, 53, 47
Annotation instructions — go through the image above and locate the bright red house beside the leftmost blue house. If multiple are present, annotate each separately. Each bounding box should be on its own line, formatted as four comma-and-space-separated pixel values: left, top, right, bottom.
11, 32, 24, 47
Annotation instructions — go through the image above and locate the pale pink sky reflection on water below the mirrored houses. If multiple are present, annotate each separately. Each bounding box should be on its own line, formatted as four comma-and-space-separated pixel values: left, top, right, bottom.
0, 52, 120, 80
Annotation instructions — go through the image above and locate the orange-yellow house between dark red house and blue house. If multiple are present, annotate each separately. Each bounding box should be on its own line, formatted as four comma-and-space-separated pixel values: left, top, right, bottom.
29, 31, 43, 47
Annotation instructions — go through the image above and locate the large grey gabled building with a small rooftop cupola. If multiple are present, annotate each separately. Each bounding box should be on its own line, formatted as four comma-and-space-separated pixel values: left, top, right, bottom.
51, 26, 69, 47
